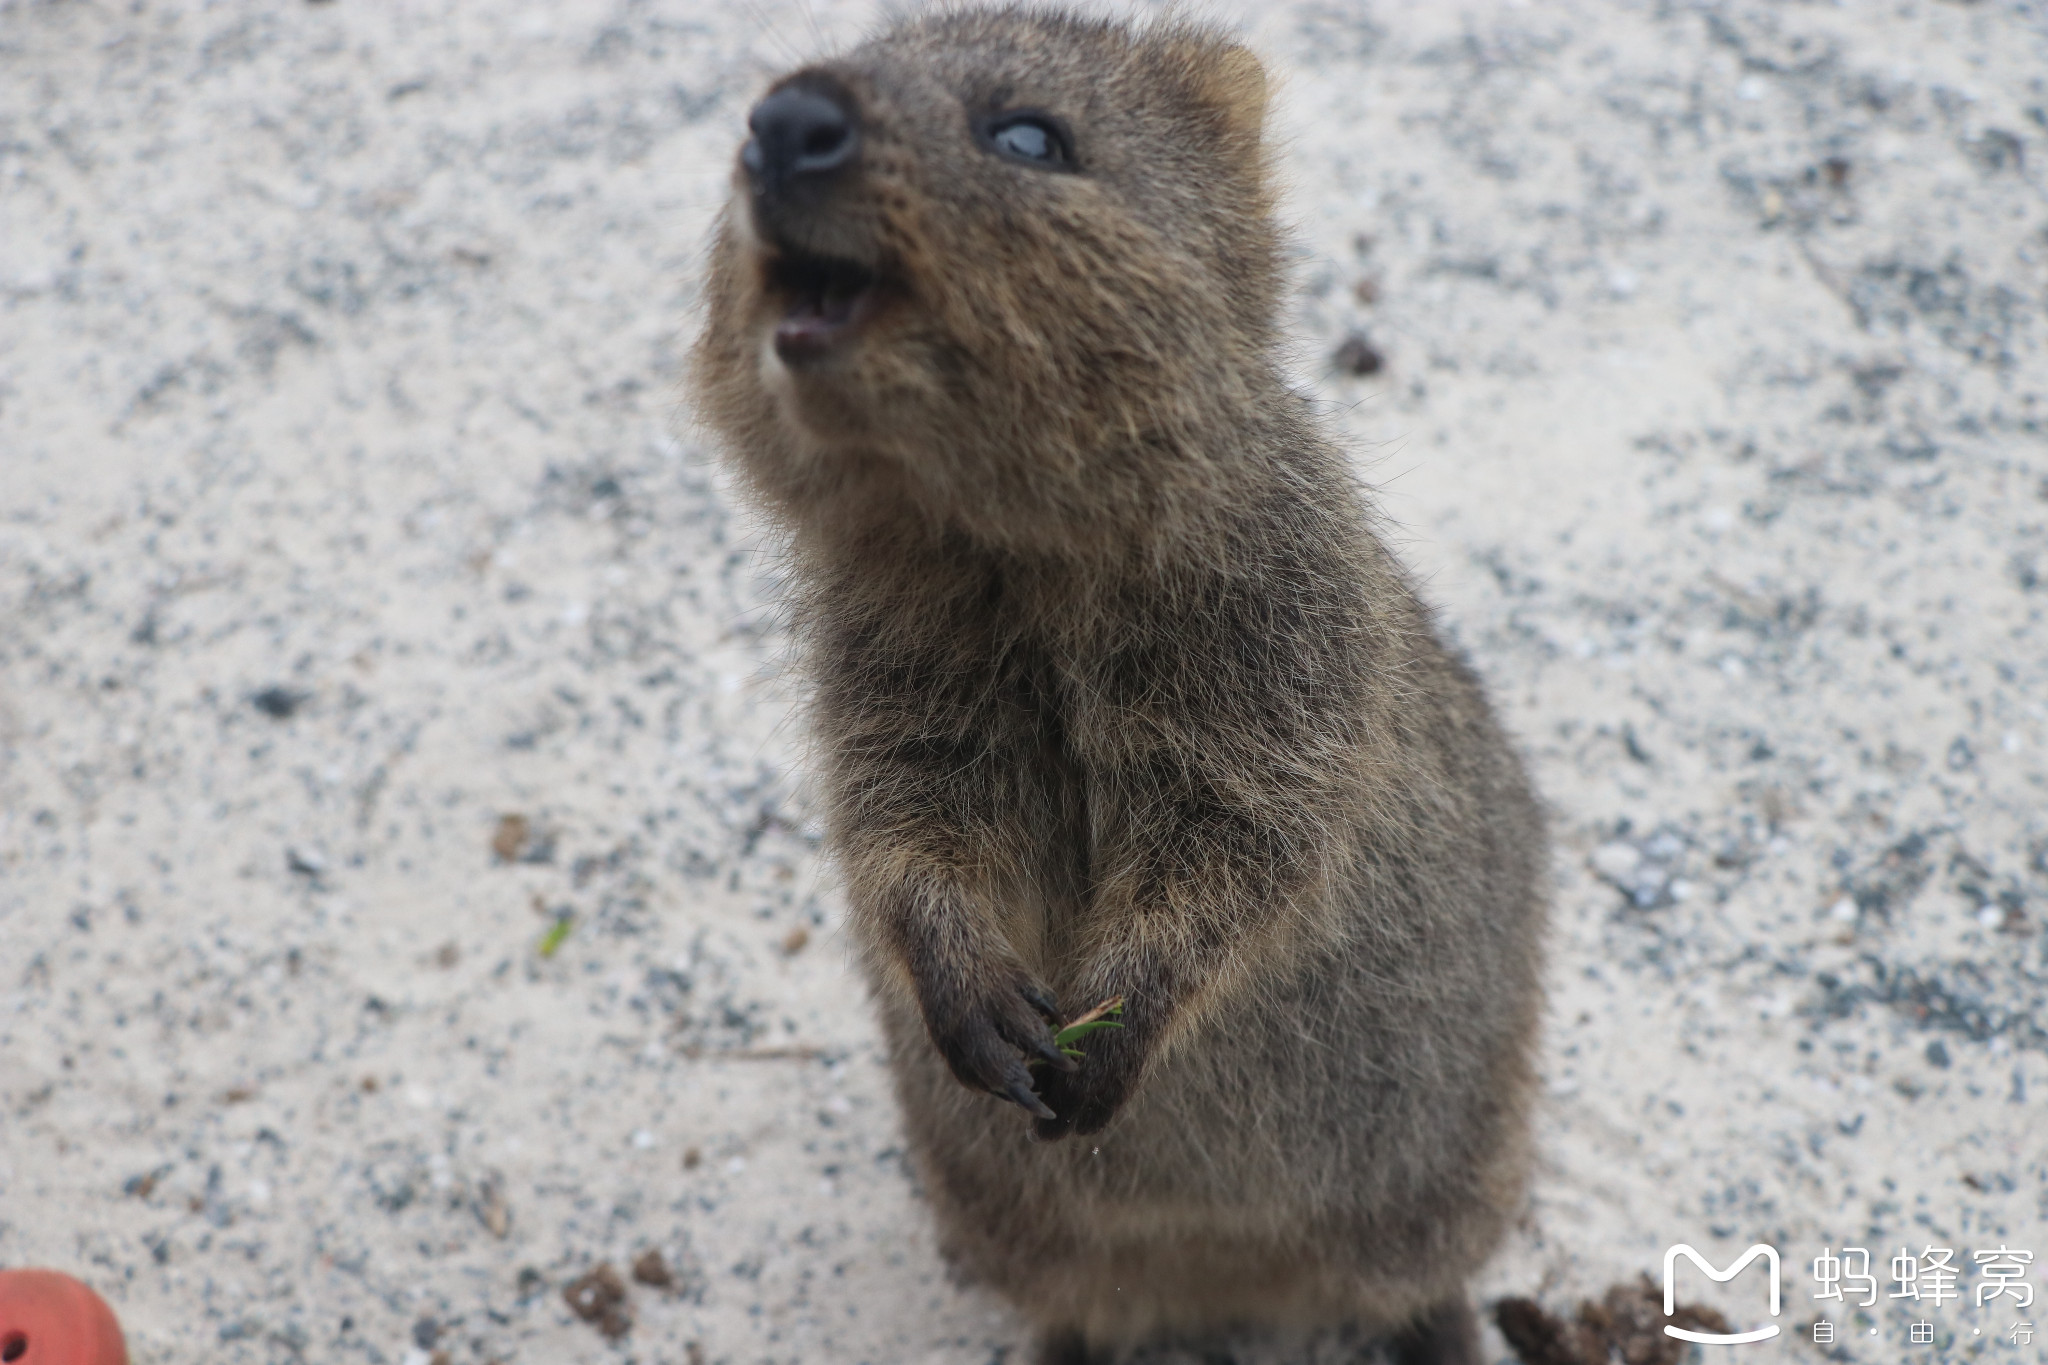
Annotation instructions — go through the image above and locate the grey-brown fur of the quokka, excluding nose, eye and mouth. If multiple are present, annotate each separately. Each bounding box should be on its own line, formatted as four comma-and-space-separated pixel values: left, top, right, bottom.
694, 10, 1544, 1361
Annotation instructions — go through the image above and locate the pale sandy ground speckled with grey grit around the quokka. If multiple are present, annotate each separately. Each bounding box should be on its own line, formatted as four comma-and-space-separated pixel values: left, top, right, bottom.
0, 0, 2048, 1365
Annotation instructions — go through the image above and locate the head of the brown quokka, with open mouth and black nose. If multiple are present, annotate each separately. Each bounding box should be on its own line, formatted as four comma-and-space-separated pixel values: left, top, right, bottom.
694, 8, 1280, 546
